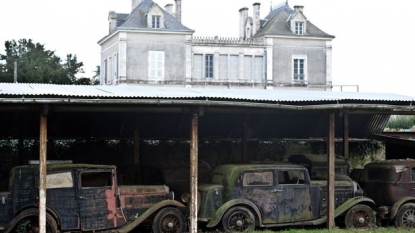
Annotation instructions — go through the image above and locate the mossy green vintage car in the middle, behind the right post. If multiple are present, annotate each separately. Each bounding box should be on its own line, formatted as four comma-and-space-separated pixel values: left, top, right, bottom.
184, 163, 375, 232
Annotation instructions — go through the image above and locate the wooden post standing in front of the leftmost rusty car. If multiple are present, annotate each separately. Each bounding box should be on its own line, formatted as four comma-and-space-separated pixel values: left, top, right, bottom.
39, 105, 48, 233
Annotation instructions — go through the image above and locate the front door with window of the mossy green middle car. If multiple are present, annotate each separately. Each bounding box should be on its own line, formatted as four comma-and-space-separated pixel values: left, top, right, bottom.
275, 168, 312, 223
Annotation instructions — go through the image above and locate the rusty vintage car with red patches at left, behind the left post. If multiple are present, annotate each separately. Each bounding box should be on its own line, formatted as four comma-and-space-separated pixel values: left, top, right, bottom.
0, 163, 186, 233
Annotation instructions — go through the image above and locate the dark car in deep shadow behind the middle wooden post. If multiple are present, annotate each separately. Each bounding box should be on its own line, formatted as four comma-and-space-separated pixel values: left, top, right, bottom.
140, 159, 211, 200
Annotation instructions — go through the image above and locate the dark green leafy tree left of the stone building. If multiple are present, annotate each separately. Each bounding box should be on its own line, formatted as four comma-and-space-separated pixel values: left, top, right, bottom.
0, 39, 92, 84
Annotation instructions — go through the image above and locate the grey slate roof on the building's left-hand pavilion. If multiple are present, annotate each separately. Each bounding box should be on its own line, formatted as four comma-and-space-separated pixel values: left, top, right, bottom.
115, 0, 193, 32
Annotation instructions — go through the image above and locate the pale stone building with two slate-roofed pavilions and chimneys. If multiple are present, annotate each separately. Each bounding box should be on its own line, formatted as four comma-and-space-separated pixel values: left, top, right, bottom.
98, 0, 334, 90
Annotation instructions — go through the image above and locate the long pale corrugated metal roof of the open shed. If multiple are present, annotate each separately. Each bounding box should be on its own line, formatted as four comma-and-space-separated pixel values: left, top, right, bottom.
0, 83, 415, 103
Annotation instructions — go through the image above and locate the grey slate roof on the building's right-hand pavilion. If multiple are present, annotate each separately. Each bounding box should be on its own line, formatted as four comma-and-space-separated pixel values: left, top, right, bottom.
255, 5, 334, 38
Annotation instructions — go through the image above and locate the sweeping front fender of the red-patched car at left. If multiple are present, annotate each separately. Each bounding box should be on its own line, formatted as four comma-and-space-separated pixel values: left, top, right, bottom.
117, 200, 186, 233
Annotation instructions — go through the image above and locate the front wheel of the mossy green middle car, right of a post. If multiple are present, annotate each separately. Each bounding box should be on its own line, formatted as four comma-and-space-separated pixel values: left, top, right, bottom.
345, 204, 373, 228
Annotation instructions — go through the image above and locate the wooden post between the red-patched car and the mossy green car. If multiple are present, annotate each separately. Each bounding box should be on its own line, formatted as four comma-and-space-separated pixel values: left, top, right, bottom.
189, 112, 199, 233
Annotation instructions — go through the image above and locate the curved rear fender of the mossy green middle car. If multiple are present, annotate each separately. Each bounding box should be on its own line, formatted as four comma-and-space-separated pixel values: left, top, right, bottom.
206, 199, 262, 227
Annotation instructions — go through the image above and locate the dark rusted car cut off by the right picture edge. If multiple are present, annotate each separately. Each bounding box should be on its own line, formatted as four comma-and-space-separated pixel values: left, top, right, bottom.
359, 159, 415, 228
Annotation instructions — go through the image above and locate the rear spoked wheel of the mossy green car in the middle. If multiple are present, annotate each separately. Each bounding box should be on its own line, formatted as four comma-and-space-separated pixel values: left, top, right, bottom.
222, 206, 255, 232
